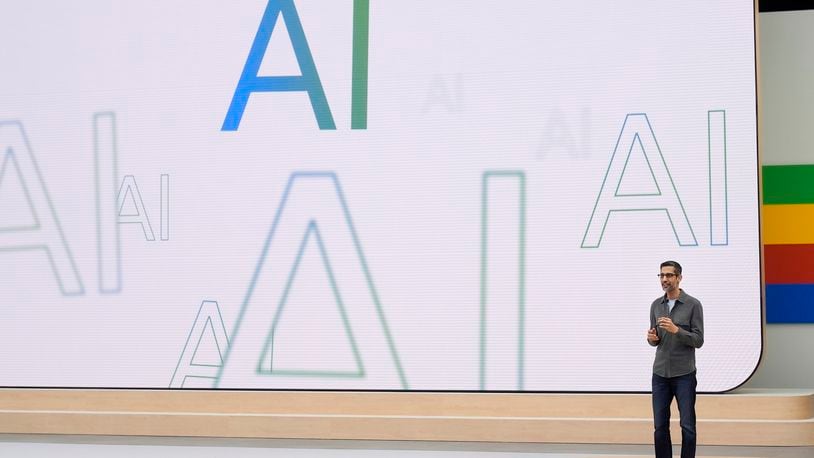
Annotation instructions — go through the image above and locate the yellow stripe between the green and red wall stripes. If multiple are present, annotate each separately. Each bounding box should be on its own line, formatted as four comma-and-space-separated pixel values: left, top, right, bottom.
763, 204, 814, 245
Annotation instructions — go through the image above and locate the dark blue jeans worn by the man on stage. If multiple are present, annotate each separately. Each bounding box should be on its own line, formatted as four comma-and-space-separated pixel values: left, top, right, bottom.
653, 372, 698, 458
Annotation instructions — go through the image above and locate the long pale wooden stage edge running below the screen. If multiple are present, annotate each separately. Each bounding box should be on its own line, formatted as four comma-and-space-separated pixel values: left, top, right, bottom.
0, 389, 814, 446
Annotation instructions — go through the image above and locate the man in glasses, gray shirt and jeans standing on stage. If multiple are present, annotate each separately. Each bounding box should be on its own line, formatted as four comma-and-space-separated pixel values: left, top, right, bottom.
647, 261, 704, 458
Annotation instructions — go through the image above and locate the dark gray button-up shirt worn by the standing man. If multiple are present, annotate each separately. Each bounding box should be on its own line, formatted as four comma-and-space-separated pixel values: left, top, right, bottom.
648, 289, 704, 377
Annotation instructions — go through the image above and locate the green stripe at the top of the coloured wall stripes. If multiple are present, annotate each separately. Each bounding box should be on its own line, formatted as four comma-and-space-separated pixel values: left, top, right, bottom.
763, 164, 814, 204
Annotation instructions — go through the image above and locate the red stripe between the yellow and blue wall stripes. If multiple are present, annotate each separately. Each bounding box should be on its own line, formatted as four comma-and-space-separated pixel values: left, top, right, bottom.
763, 244, 814, 285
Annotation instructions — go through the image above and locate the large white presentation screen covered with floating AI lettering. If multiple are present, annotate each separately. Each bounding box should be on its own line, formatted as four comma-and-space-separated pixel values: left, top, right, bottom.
0, 0, 762, 392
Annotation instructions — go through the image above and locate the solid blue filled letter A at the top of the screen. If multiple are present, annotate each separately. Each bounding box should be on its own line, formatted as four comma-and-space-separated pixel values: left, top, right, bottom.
221, 0, 336, 130
